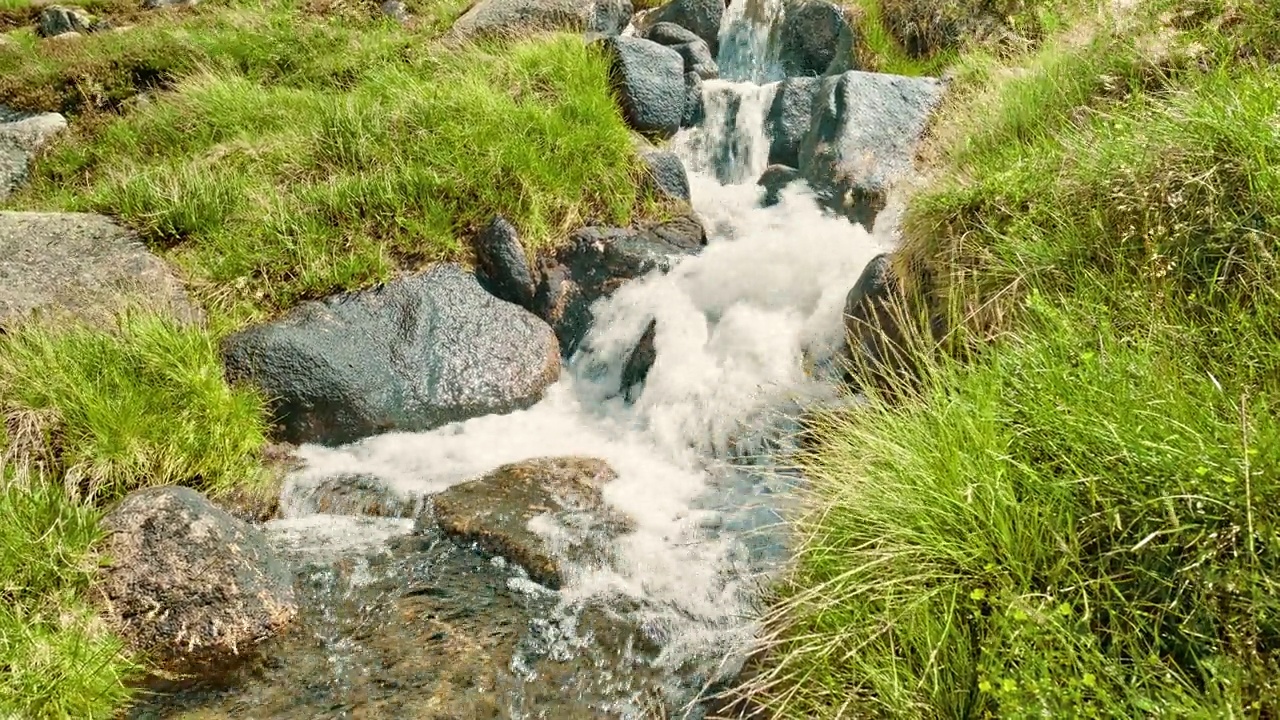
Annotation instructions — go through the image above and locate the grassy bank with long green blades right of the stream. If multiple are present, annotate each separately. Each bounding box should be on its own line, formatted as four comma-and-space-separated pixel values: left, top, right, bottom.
753, 0, 1280, 717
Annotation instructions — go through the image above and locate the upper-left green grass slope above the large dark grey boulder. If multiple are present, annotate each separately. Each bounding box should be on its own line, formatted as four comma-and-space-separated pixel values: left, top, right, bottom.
0, 9, 649, 324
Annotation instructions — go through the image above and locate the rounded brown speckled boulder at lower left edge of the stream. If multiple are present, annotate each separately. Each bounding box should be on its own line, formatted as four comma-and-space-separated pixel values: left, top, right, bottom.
95, 487, 297, 674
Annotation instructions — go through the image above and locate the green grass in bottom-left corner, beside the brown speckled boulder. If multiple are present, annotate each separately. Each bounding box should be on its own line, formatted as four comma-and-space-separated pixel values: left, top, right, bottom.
0, 470, 136, 720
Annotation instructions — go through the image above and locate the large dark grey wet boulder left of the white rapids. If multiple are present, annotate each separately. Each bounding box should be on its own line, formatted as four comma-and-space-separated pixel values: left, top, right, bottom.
223, 264, 561, 445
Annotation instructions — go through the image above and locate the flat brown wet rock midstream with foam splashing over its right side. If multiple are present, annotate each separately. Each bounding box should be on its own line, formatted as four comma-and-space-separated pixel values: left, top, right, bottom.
433, 457, 631, 589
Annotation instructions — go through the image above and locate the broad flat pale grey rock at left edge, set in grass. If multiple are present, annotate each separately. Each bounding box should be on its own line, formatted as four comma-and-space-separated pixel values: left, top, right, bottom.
0, 213, 201, 328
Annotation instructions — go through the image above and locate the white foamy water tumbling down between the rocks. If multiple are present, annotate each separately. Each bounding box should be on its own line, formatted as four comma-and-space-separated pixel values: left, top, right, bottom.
275, 0, 884, 686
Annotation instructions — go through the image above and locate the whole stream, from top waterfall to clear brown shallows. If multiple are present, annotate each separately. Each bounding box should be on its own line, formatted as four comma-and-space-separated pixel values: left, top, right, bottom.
133, 3, 887, 720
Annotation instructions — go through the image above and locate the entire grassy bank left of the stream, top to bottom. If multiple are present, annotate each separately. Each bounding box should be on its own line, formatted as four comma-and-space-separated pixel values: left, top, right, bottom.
0, 0, 658, 719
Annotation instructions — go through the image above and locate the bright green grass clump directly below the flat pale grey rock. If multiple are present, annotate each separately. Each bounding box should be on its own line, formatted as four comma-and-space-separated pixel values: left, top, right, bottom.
0, 314, 266, 502
